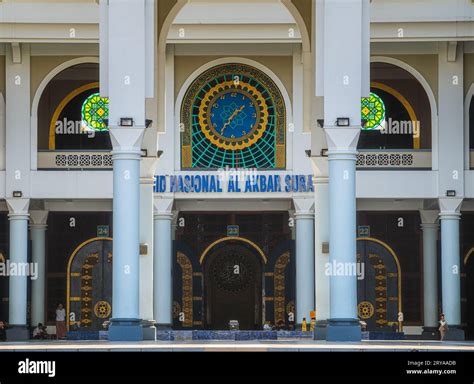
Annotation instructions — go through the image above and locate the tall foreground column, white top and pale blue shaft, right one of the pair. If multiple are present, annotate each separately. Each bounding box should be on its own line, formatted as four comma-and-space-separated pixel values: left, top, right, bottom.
322, 0, 370, 341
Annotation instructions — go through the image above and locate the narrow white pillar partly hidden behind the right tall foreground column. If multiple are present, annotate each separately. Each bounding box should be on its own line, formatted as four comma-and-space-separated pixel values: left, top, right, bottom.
311, 157, 330, 340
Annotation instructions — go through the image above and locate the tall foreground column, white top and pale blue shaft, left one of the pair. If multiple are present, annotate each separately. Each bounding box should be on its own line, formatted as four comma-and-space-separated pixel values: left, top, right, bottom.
100, 0, 148, 341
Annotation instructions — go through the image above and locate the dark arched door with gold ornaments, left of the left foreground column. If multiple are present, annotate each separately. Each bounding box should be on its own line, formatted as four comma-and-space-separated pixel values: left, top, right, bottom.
66, 237, 112, 331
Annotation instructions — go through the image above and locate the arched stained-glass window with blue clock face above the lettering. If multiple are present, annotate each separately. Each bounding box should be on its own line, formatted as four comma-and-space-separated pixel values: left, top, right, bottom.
181, 64, 286, 169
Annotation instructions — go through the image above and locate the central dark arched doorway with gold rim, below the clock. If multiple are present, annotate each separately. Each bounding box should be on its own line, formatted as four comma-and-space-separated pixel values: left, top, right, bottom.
201, 238, 266, 330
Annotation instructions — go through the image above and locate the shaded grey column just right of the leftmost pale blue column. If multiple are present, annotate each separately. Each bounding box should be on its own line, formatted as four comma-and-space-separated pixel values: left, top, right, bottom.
30, 211, 48, 326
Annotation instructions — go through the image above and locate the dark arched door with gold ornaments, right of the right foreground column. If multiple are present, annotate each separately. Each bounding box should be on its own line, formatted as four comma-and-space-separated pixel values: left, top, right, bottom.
357, 237, 402, 331
